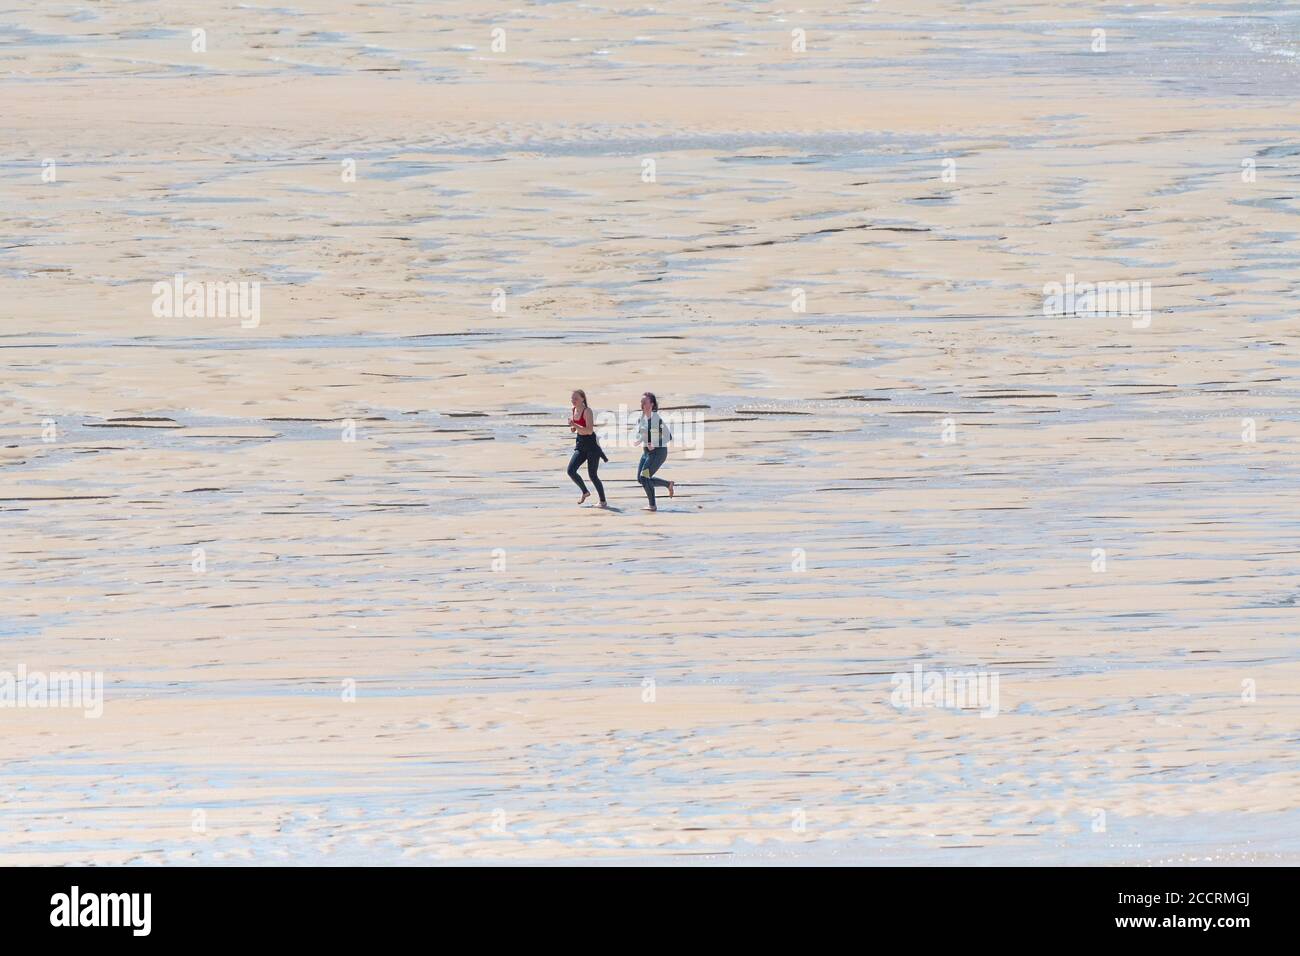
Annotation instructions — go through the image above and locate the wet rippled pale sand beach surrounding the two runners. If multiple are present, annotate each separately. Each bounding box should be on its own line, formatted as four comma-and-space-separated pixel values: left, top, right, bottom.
0, 0, 1300, 865
